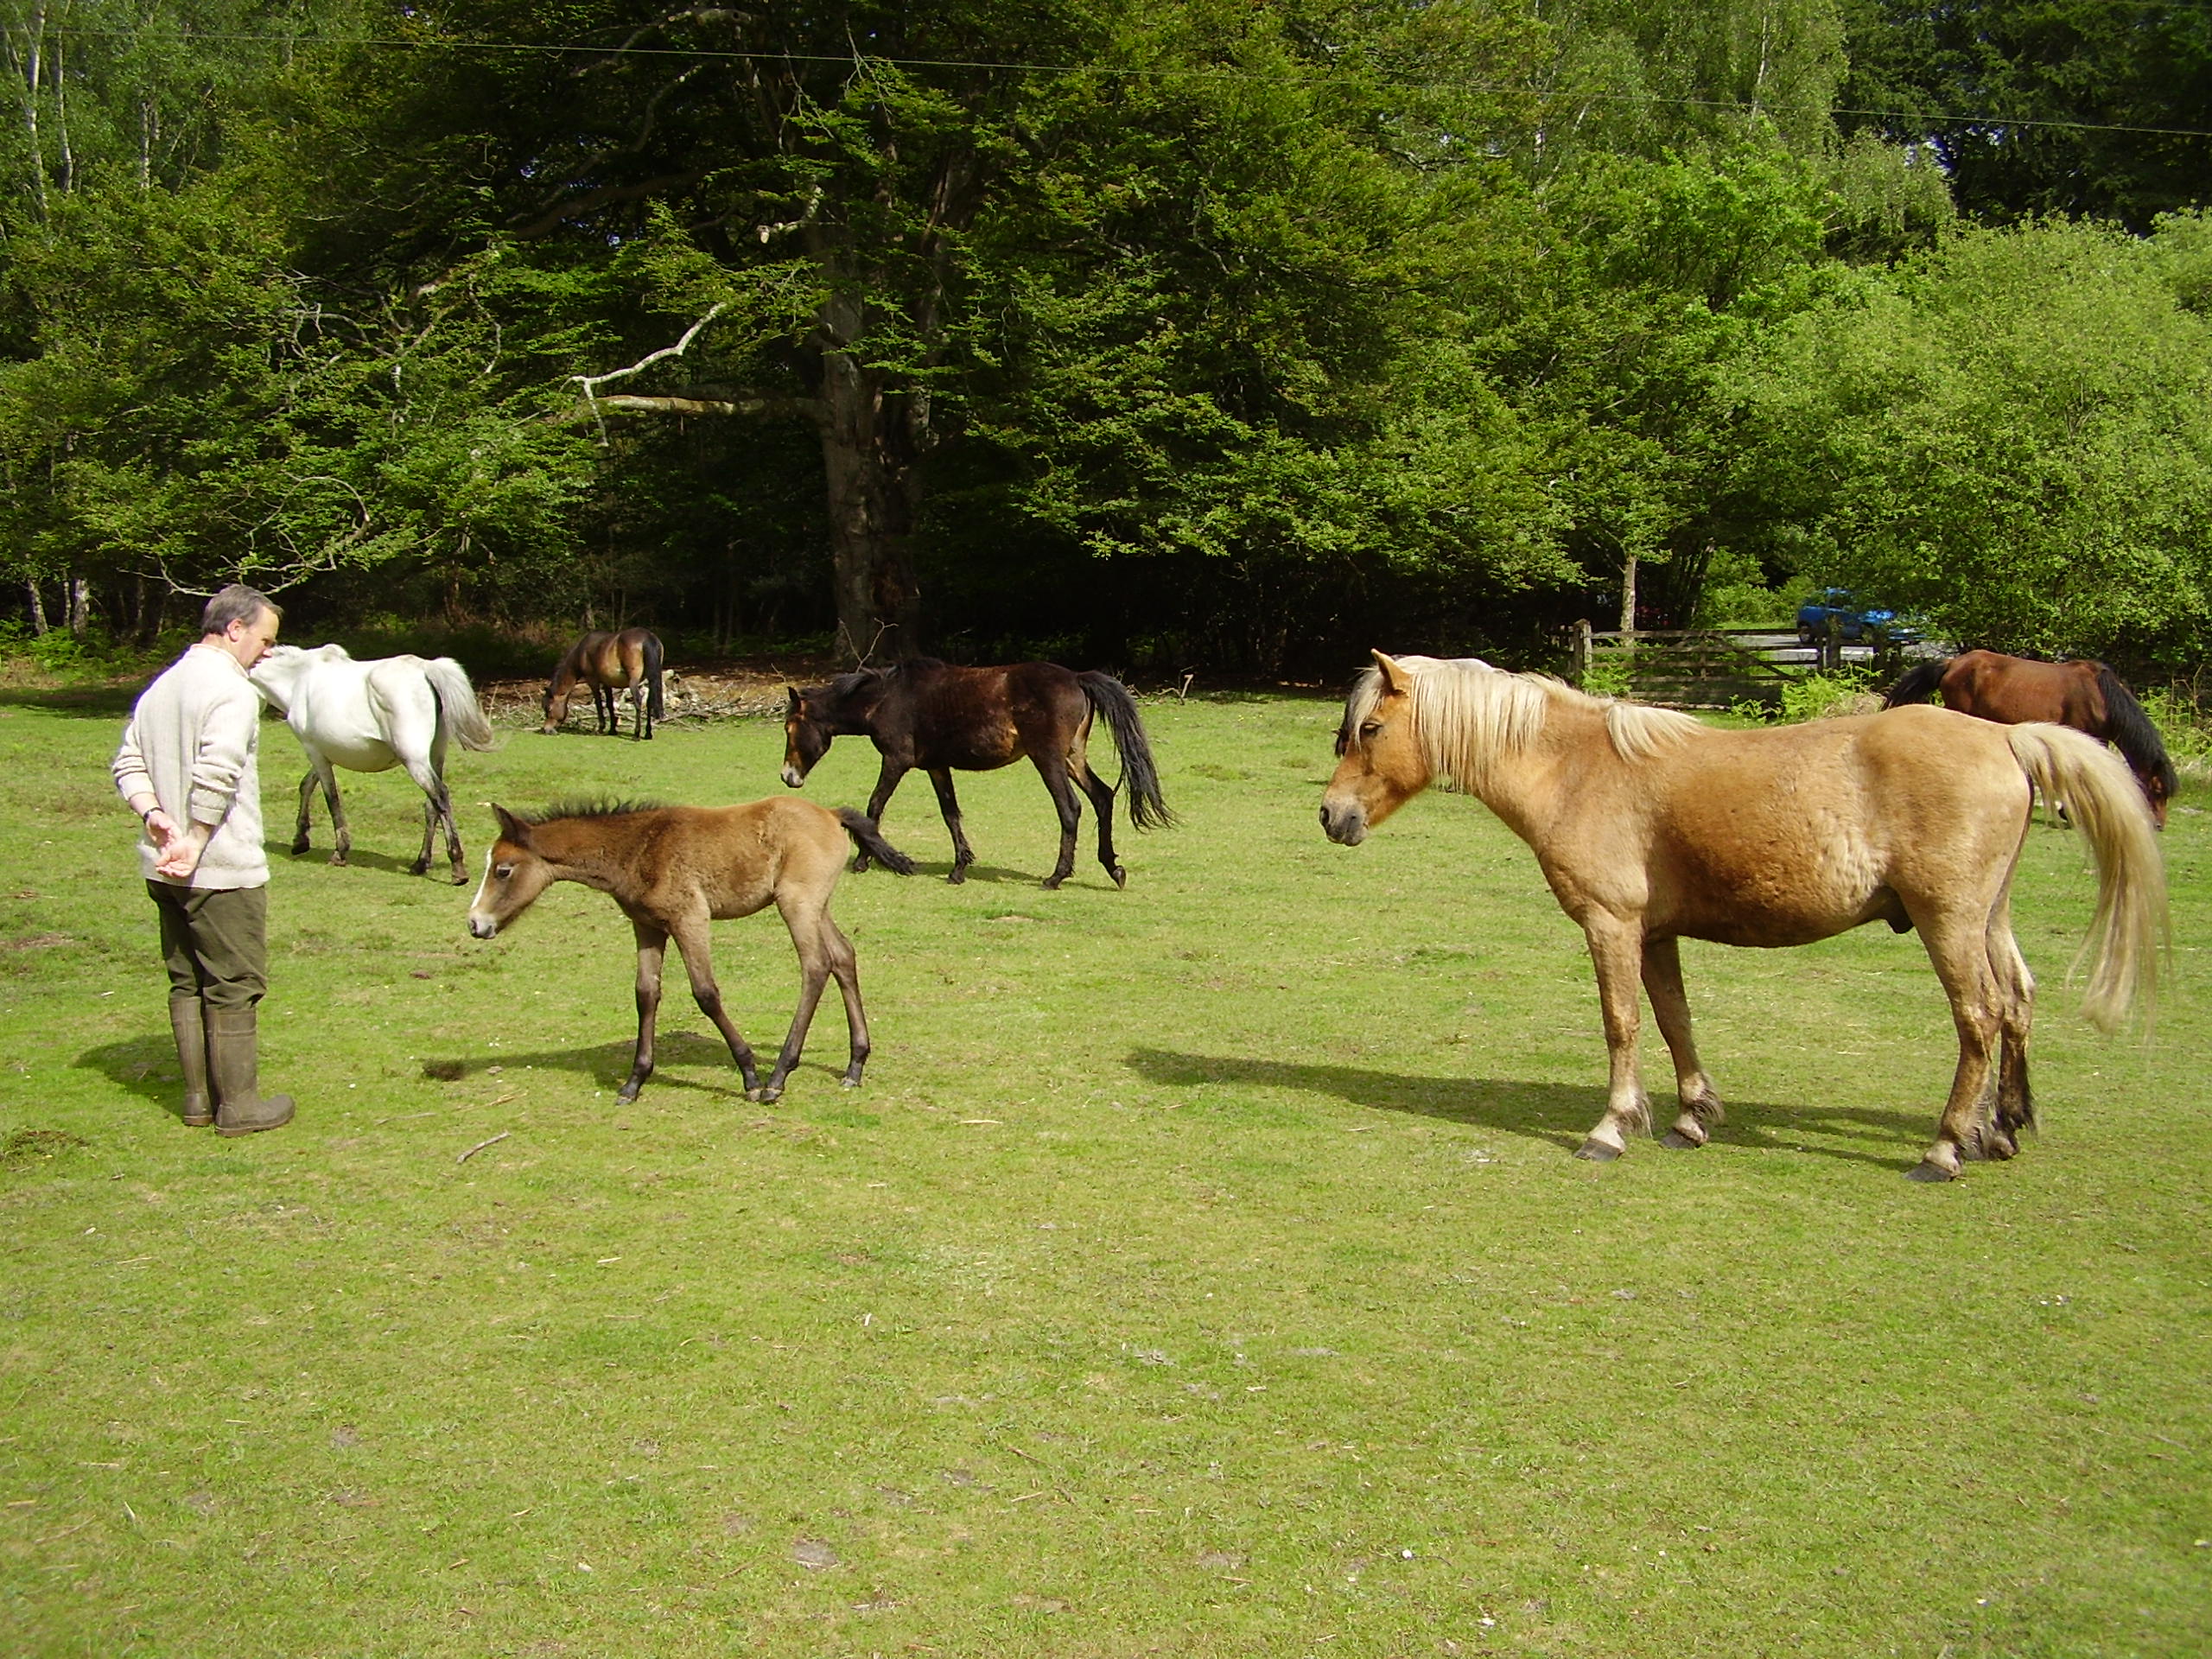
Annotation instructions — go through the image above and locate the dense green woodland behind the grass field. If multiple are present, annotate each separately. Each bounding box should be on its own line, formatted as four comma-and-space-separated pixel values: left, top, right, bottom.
0, 0, 2212, 675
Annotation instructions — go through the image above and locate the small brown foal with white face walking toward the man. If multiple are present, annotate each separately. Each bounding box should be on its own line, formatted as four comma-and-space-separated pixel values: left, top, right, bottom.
469, 797, 913, 1102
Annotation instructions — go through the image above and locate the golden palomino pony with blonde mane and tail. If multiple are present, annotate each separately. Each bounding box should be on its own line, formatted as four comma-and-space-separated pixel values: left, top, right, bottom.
1320, 651, 2165, 1181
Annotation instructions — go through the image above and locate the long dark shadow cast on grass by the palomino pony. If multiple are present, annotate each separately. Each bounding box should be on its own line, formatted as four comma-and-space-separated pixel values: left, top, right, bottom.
1128, 1048, 1936, 1170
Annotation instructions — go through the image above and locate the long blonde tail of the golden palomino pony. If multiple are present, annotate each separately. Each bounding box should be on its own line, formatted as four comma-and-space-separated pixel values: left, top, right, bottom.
2004, 723, 2172, 1031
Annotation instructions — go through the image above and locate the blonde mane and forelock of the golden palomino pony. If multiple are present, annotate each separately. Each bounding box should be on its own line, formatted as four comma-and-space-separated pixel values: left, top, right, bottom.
1344, 657, 1706, 791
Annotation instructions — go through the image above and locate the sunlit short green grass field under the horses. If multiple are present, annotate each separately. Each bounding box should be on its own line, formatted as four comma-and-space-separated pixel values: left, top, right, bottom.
0, 692, 2212, 1659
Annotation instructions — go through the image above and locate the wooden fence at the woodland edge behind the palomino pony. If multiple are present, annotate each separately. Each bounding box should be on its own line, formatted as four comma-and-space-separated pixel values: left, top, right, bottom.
1566, 621, 1904, 708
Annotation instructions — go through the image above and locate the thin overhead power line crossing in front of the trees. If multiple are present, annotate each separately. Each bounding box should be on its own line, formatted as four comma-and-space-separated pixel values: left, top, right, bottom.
26, 26, 2212, 139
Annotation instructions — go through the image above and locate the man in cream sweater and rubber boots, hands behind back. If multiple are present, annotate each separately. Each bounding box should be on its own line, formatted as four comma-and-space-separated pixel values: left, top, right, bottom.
115, 582, 292, 1135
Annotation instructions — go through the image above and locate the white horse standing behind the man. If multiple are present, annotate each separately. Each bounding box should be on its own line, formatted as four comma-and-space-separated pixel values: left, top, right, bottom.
252, 646, 491, 887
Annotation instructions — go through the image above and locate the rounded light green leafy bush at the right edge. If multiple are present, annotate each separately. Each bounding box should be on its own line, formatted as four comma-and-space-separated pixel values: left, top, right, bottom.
1738, 224, 2212, 657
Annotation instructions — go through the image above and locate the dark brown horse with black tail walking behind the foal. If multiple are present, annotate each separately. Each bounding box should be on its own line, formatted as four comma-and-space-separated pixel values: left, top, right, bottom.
783, 657, 1174, 887
